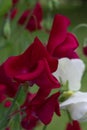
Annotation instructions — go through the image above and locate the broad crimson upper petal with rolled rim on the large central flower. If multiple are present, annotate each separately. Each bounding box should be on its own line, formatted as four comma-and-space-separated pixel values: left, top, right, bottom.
4, 38, 58, 81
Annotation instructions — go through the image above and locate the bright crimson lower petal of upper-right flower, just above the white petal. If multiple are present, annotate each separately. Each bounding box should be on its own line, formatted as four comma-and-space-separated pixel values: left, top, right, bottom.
53, 33, 79, 58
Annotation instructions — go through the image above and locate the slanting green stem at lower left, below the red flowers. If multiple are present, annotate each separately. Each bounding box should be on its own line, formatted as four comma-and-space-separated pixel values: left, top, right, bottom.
0, 86, 22, 129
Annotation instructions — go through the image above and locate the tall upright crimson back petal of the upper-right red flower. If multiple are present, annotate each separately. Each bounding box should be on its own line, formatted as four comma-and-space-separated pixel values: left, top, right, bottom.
47, 15, 70, 54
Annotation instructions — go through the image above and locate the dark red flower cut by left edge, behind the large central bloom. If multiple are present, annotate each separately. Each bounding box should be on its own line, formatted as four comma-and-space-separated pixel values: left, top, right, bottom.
0, 65, 18, 101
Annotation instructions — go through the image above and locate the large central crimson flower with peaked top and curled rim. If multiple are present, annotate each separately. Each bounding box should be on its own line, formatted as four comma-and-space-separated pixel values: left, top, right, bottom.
4, 38, 59, 89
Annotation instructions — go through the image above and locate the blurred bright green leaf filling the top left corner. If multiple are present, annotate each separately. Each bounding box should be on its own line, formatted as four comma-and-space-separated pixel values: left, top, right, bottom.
0, 0, 12, 17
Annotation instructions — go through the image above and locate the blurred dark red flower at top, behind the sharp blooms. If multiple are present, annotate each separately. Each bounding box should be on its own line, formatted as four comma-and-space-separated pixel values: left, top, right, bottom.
18, 3, 43, 32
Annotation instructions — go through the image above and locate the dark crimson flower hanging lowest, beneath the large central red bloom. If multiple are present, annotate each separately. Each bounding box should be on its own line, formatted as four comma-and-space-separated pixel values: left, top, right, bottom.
21, 92, 60, 130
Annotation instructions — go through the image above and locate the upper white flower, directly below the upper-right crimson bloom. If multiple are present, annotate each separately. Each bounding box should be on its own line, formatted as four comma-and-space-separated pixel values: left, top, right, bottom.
53, 58, 85, 91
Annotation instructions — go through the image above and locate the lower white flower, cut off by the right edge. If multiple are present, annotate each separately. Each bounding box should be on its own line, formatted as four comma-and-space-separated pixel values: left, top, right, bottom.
60, 91, 87, 121
